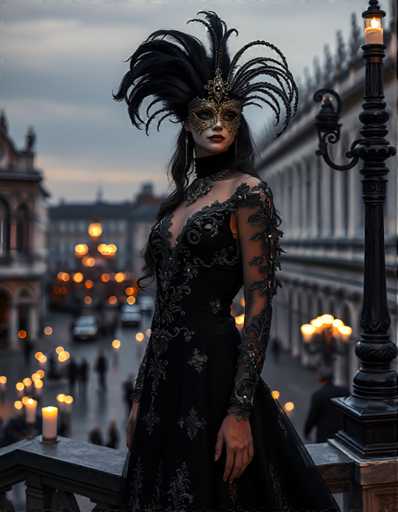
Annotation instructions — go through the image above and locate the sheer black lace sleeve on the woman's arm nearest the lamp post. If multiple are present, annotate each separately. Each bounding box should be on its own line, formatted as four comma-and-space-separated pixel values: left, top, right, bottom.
227, 177, 284, 418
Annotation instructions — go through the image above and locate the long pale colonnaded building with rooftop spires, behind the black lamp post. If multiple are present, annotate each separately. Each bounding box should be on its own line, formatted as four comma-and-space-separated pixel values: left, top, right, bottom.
258, 6, 398, 385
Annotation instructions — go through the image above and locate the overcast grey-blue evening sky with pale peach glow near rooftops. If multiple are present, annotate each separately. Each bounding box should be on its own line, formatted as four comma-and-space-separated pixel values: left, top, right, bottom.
0, 0, 389, 203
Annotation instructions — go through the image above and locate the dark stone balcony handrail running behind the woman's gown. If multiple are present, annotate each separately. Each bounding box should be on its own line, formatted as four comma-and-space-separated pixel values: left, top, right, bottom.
0, 436, 354, 512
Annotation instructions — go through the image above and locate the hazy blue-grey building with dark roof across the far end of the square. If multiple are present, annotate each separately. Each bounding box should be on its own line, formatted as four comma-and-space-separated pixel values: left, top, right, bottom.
48, 182, 163, 286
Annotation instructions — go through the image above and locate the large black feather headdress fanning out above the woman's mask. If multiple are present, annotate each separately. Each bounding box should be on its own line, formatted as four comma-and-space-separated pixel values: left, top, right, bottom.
113, 11, 298, 137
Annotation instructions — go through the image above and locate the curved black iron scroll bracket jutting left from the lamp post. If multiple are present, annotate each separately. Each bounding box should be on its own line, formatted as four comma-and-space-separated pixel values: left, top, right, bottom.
314, 89, 365, 171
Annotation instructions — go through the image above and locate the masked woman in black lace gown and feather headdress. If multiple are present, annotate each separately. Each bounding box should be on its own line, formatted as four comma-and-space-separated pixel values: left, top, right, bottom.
114, 11, 339, 512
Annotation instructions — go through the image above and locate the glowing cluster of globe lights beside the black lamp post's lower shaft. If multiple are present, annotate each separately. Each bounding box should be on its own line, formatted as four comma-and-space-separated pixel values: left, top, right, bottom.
300, 315, 352, 367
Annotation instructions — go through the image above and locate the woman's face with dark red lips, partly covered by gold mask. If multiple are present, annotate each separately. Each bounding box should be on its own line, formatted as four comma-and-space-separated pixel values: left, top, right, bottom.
184, 98, 241, 157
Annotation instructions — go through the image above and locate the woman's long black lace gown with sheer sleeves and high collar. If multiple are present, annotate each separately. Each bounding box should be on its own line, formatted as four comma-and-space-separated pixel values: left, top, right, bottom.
126, 148, 339, 512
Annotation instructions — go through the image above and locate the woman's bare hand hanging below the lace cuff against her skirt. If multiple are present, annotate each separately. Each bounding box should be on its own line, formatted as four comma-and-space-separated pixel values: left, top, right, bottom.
215, 414, 254, 482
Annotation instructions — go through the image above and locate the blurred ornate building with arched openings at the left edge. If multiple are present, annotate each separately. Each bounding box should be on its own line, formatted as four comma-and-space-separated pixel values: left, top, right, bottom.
0, 111, 50, 349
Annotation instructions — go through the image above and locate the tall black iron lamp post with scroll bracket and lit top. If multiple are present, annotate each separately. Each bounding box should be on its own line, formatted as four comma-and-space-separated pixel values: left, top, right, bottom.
314, 0, 398, 459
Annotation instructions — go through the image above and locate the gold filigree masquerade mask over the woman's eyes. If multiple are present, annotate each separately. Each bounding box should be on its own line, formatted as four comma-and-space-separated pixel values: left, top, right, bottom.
188, 68, 242, 135
